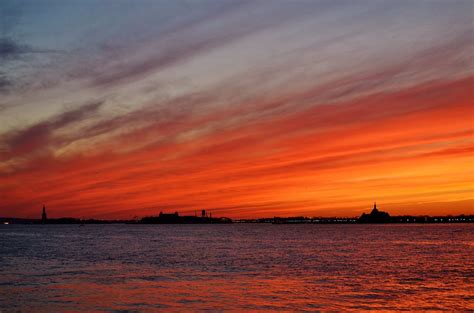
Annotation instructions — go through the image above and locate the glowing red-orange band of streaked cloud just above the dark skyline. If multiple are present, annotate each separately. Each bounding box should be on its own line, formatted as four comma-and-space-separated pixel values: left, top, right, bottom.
0, 78, 474, 218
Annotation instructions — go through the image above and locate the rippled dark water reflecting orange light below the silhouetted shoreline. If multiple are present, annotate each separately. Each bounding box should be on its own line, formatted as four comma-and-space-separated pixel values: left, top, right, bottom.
0, 224, 474, 312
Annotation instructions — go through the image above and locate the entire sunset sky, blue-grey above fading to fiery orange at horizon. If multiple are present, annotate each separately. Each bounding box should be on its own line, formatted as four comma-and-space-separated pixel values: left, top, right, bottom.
0, 0, 474, 218
